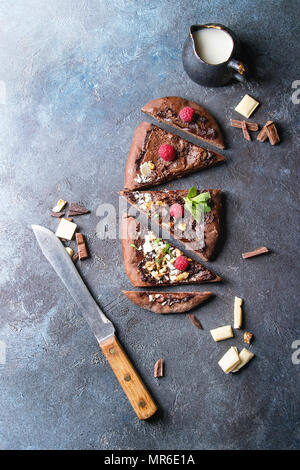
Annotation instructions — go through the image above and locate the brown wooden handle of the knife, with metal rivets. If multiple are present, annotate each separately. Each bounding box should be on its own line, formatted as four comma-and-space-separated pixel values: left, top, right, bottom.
100, 336, 157, 419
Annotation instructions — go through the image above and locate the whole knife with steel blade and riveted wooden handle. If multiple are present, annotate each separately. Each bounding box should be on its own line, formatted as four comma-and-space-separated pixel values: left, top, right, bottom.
32, 225, 157, 419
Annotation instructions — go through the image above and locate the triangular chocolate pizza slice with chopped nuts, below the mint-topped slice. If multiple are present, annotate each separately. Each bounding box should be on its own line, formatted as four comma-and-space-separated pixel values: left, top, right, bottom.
121, 214, 221, 287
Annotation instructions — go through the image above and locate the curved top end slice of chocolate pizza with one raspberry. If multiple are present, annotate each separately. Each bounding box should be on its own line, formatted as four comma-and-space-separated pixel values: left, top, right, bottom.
142, 96, 225, 149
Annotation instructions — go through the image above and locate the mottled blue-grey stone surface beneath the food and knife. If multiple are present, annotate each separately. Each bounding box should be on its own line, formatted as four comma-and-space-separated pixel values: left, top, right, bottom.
0, 0, 300, 449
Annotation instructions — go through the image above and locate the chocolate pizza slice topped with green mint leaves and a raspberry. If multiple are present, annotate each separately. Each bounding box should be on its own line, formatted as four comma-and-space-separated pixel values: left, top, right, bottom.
120, 187, 222, 261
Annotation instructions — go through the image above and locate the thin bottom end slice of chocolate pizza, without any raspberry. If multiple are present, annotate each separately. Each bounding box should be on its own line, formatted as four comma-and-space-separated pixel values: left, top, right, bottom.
122, 290, 212, 314
